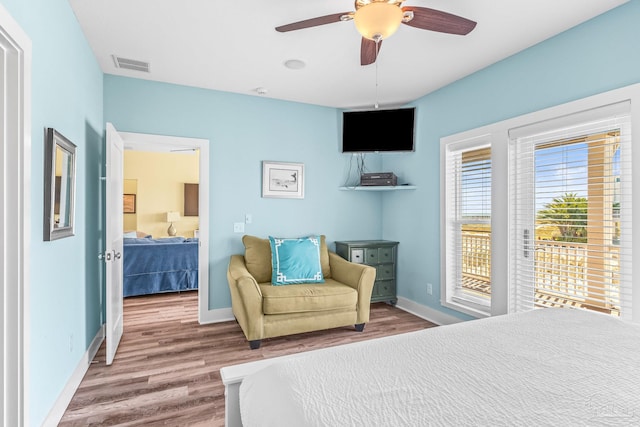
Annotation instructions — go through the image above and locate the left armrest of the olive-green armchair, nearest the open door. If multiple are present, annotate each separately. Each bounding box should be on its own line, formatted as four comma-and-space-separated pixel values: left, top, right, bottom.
227, 255, 264, 341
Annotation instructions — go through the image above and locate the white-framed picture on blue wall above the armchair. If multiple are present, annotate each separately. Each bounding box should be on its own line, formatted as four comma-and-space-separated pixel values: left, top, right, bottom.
262, 161, 304, 199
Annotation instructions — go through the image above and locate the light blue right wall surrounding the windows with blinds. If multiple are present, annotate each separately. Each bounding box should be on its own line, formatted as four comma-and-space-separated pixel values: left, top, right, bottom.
383, 0, 640, 318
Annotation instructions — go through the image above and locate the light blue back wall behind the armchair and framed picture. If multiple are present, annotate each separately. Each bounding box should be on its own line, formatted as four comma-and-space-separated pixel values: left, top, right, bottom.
104, 75, 382, 309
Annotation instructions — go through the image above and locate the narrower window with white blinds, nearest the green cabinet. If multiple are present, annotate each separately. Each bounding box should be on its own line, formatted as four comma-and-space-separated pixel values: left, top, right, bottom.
443, 141, 491, 314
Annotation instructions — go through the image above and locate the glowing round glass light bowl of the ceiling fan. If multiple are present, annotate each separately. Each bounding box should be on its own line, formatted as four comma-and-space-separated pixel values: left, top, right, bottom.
353, 2, 403, 41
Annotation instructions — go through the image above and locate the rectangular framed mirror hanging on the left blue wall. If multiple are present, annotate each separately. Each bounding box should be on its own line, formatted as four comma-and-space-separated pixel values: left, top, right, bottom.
44, 128, 76, 241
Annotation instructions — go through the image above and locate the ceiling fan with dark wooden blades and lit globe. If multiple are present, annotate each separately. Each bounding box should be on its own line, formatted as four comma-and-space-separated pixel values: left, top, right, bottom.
276, 0, 476, 65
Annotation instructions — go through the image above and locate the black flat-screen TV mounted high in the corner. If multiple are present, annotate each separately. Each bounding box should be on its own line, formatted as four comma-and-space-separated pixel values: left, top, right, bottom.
342, 108, 415, 153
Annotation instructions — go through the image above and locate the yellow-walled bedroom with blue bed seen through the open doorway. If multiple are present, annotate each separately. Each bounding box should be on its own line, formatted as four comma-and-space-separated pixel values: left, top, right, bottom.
123, 147, 200, 312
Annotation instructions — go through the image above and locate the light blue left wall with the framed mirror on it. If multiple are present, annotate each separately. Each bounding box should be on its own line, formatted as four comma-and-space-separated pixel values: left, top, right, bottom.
2, 0, 104, 426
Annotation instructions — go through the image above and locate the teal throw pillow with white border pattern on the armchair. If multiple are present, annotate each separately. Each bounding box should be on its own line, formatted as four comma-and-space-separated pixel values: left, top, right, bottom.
269, 236, 324, 285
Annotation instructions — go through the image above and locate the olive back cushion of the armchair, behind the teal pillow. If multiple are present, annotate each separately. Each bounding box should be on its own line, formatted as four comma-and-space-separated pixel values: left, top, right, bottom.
242, 235, 331, 283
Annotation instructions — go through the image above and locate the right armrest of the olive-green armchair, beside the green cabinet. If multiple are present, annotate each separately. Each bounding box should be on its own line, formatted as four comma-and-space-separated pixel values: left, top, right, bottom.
329, 252, 376, 323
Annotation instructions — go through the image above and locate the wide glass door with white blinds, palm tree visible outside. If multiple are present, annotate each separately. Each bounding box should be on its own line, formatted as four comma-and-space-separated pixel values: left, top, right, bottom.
509, 102, 632, 318
